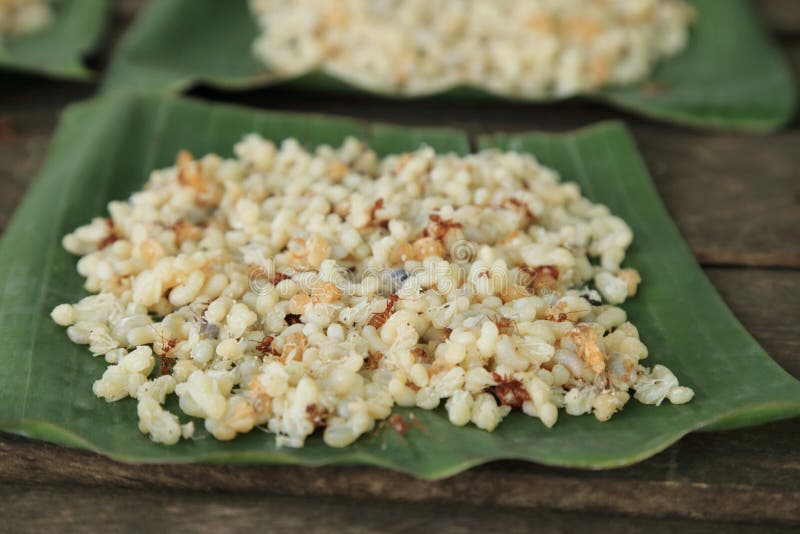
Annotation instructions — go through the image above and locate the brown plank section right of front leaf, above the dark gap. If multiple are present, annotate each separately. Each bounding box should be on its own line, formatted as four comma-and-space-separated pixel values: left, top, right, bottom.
635, 126, 800, 267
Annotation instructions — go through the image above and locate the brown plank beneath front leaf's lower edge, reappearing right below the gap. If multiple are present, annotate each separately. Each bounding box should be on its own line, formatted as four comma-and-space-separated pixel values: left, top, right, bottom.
0, 269, 800, 522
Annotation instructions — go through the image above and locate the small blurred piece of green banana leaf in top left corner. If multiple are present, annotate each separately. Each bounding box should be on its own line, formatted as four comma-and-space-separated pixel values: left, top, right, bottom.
0, 0, 108, 80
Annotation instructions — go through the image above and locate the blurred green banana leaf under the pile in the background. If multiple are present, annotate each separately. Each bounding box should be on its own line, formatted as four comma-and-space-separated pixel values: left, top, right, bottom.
104, 0, 796, 131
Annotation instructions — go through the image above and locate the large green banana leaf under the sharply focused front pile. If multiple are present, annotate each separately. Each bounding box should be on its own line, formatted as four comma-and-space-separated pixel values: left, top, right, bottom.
0, 94, 800, 478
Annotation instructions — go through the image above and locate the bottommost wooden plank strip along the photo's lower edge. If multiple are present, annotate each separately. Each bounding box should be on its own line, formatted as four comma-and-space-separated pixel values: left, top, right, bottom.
0, 486, 790, 534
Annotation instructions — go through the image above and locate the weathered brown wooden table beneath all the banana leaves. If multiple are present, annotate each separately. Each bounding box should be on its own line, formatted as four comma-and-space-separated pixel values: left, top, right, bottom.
0, 0, 800, 533
